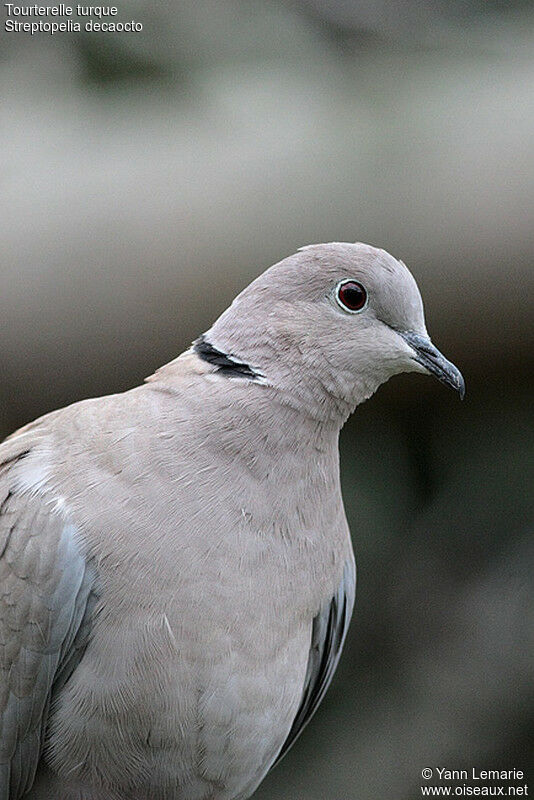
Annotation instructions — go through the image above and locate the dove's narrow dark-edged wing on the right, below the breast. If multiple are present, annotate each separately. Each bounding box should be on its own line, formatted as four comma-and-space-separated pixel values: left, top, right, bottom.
273, 561, 356, 766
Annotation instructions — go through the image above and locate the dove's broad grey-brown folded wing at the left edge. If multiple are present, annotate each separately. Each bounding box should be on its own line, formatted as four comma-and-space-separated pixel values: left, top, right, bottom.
0, 456, 93, 800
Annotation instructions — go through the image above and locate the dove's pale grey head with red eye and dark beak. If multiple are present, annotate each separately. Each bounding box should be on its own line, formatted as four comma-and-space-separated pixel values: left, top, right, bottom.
201, 242, 464, 416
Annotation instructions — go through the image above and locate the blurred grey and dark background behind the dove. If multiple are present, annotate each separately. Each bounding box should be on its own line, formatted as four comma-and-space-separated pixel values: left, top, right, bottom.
0, 0, 534, 800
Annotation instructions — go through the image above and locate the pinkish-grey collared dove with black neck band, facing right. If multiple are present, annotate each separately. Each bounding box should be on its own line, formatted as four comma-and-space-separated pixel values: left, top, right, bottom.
0, 242, 465, 800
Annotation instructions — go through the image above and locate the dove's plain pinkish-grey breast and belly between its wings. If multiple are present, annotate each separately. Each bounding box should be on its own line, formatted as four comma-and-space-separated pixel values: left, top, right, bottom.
23, 384, 351, 800
